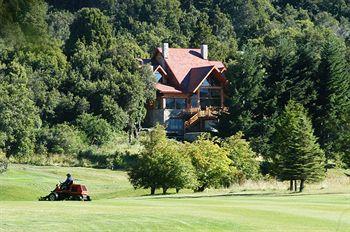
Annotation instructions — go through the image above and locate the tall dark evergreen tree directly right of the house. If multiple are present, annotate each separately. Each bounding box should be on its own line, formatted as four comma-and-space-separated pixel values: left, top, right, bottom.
217, 43, 268, 153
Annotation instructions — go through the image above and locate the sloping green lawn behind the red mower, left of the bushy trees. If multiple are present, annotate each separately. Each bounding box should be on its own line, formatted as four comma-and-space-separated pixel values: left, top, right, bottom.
0, 165, 148, 201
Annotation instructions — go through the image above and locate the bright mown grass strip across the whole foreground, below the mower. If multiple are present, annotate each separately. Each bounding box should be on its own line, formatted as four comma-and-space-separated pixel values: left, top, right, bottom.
0, 194, 350, 232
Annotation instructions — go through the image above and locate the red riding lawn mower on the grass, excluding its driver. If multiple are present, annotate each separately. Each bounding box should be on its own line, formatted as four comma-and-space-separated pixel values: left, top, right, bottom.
39, 184, 91, 201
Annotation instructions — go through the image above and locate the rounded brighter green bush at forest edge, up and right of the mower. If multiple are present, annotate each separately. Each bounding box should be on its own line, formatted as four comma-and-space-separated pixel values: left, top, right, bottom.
77, 114, 113, 146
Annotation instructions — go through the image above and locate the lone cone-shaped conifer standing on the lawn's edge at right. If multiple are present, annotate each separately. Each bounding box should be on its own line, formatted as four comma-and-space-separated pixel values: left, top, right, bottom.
272, 101, 325, 192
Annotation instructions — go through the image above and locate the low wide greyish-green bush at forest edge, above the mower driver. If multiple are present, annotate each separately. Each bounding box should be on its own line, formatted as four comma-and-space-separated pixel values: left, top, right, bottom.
36, 124, 86, 154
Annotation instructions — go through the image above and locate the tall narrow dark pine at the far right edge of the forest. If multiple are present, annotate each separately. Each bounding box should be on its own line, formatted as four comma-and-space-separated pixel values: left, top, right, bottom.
315, 36, 350, 158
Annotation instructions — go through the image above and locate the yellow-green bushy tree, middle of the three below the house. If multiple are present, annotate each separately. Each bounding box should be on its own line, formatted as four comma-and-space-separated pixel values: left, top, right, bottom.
186, 136, 234, 192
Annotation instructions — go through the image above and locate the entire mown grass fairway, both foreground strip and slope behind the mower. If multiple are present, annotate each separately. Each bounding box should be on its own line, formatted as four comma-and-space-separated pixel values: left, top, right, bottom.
0, 166, 350, 231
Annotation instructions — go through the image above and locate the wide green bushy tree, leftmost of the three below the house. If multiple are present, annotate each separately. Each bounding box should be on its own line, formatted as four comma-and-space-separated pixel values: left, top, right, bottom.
128, 126, 196, 195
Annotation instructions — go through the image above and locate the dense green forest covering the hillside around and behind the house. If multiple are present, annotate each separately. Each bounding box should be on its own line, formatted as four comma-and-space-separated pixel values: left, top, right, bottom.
0, 0, 350, 167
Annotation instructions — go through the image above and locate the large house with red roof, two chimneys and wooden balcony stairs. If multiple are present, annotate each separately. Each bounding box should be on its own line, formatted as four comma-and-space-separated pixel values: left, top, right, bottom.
143, 43, 227, 138
